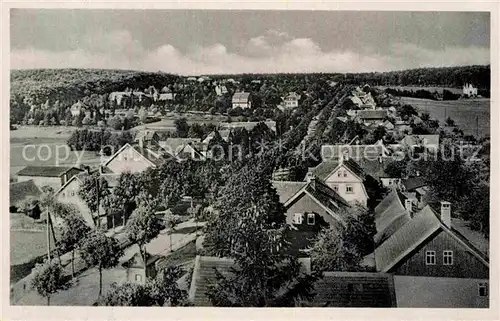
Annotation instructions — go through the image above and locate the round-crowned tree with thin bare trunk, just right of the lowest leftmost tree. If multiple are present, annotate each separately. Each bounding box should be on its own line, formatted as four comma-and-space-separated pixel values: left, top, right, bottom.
80, 231, 123, 297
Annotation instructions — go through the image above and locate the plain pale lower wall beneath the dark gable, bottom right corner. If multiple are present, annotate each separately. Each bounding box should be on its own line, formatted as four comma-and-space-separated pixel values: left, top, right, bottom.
394, 275, 489, 308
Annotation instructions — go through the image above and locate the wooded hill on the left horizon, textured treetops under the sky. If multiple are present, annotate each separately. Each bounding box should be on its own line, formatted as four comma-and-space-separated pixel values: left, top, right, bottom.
10, 69, 178, 102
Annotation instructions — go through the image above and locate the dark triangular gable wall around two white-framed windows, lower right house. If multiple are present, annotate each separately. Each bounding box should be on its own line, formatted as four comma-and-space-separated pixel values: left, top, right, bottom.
390, 231, 489, 279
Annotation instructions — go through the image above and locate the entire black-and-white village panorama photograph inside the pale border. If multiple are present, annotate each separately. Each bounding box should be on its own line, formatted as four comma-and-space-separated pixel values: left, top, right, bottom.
3, 7, 498, 311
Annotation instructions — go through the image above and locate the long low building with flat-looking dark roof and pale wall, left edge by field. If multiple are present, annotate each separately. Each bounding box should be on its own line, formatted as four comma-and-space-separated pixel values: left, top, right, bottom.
17, 166, 83, 190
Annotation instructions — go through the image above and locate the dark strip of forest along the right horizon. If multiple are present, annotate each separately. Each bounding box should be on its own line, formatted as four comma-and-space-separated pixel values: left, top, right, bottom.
334, 65, 490, 90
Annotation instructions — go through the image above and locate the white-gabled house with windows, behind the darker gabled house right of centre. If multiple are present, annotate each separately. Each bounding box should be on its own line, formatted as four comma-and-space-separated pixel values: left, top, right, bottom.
308, 156, 368, 206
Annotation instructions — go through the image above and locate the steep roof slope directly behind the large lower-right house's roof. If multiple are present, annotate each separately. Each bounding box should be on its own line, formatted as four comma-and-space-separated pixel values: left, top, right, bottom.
373, 189, 411, 244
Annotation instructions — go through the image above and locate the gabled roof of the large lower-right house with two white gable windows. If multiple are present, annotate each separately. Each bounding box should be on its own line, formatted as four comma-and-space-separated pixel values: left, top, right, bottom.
375, 205, 489, 272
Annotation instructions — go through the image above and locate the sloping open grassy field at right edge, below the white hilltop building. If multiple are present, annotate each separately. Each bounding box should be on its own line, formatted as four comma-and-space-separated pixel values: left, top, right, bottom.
401, 97, 490, 137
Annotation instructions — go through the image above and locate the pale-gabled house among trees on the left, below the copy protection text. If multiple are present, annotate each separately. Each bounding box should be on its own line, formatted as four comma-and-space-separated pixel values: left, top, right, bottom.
104, 143, 166, 174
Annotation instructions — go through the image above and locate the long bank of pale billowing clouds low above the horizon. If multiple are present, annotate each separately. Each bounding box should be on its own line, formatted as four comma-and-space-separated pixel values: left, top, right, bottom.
10, 30, 490, 75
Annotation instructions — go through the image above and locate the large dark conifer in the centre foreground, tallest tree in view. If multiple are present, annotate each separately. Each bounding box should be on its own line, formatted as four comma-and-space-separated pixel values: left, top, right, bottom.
205, 166, 318, 307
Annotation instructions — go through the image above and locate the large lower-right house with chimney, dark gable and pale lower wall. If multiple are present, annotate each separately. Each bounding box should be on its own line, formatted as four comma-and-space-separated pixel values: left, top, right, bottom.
374, 199, 489, 308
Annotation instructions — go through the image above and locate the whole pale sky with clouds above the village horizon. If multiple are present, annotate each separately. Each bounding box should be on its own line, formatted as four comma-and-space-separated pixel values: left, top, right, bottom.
10, 9, 490, 75
